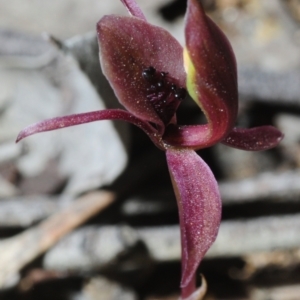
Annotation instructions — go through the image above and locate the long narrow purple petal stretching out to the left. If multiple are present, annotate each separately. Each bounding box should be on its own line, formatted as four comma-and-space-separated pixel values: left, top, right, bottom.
16, 109, 163, 149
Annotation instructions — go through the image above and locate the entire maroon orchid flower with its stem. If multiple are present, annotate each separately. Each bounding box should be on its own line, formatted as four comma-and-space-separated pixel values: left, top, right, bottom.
17, 0, 283, 299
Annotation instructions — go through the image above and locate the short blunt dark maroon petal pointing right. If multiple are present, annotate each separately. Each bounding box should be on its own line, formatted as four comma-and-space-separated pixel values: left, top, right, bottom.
222, 126, 283, 151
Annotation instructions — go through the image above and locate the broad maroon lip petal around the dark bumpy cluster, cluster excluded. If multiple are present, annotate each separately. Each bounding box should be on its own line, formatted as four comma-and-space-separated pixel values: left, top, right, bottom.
98, 16, 186, 131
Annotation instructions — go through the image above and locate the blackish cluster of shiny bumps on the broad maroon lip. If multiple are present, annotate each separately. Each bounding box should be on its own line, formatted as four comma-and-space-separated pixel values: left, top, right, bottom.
142, 66, 186, 125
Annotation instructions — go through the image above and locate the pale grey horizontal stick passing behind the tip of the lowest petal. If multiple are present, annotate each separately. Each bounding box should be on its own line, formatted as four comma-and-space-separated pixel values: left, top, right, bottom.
44, 214, 300, 272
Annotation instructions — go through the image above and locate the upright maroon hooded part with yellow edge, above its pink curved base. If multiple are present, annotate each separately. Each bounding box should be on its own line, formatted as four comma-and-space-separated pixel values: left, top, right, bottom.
184, 0, 238, 144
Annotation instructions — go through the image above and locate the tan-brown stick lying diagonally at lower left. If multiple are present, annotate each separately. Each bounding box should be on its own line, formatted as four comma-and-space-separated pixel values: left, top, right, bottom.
0, 191, 114, 288
